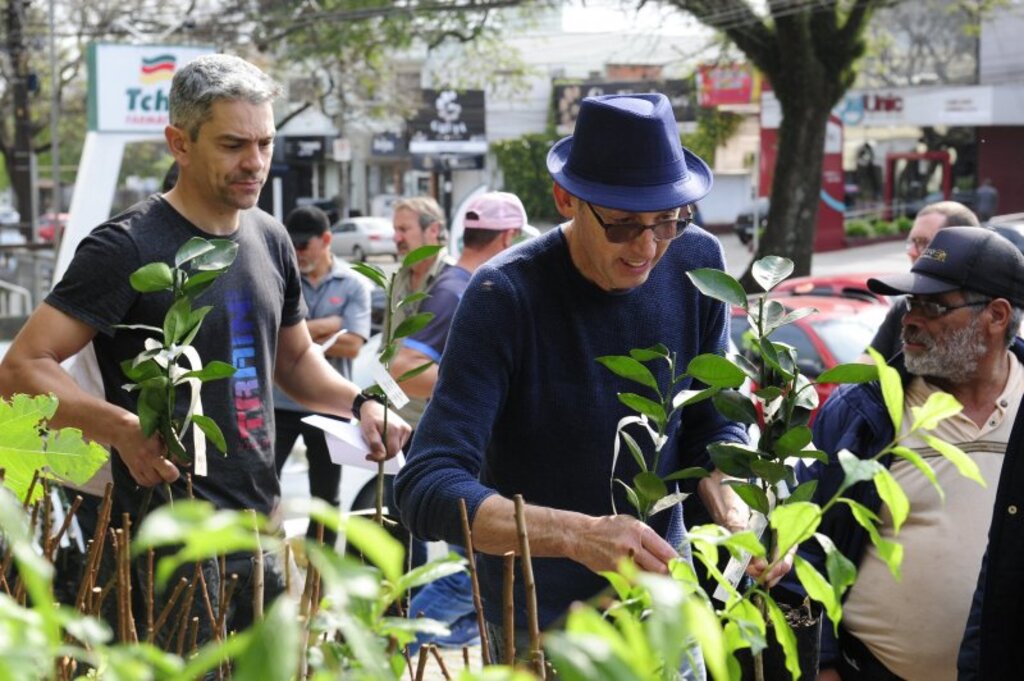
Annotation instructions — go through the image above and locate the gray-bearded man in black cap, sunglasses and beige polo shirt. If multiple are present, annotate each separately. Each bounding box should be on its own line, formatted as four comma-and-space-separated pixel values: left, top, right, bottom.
798, 227, 1024, 681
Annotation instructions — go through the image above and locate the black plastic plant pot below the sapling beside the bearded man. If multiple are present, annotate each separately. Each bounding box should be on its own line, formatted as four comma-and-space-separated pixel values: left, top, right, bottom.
736, 587, 823, 681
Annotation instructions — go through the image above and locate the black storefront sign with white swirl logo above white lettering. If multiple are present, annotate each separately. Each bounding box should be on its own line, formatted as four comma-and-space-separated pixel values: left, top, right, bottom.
409, 90, 487, 154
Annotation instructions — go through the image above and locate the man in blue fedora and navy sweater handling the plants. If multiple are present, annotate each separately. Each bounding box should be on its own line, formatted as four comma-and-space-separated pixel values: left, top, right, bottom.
396, 94, 775, 658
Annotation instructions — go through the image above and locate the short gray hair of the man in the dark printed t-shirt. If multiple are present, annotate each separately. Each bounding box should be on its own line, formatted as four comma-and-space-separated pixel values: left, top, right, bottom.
169, 54, 281, 140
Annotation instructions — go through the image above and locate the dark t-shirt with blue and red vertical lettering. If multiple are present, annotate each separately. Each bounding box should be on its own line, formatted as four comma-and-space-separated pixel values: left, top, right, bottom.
46, 196, 305, 514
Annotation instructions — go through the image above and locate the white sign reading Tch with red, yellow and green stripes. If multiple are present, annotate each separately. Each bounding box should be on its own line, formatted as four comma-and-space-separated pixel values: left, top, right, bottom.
88, 43, 216, 133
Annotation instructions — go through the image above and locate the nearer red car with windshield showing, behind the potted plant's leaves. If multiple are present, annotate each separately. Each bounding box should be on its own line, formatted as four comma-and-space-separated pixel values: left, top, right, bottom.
731, 288, 889, 411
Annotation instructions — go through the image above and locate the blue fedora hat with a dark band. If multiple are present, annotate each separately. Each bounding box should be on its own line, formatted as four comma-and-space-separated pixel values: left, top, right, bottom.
548, 93, 713, 212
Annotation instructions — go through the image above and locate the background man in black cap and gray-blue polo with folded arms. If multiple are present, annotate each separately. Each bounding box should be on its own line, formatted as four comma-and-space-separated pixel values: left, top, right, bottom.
273, 206, 370, 546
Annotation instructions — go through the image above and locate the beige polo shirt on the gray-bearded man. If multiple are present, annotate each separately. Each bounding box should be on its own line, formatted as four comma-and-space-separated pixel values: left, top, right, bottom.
843, 354, 1024, 681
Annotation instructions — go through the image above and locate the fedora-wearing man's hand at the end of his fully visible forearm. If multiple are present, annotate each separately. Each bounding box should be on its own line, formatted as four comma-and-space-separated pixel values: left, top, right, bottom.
568, 515, 679, 574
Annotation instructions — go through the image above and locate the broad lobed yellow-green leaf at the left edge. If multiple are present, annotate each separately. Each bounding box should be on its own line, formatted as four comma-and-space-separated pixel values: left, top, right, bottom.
0, 394, 109, 501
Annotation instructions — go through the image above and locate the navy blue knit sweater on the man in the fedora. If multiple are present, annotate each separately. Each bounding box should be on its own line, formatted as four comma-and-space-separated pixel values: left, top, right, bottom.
395, 227, 745, 627
